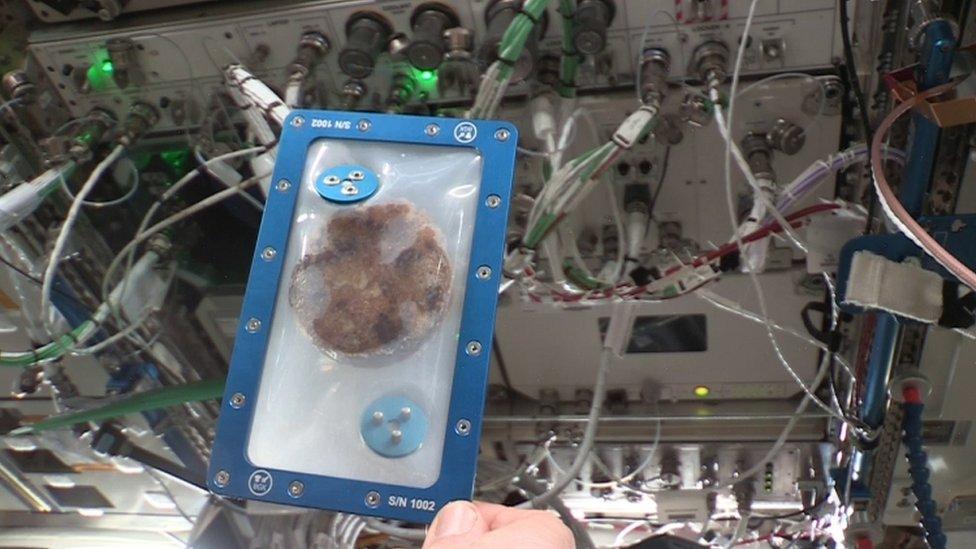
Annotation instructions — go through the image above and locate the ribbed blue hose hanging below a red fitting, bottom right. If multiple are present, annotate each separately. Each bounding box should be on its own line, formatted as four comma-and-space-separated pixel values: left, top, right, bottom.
902, 402, 947, 549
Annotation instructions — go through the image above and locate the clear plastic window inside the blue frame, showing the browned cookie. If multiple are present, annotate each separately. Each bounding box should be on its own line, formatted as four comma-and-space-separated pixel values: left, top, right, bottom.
247, 139, 482, 488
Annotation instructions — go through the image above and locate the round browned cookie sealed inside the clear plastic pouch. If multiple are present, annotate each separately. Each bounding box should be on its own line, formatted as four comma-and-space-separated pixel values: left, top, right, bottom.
288, 202, 451, 356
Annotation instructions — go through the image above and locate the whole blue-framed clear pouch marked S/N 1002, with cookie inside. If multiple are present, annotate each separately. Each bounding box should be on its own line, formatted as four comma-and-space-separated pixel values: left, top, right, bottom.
210, 111, 516, 520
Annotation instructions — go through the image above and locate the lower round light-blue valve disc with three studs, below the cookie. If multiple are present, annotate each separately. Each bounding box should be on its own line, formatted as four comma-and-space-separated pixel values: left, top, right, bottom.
360, 396, 427, 458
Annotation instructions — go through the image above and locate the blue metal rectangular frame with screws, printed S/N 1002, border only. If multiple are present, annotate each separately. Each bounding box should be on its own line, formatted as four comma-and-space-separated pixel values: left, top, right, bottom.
207, 110, 518, 523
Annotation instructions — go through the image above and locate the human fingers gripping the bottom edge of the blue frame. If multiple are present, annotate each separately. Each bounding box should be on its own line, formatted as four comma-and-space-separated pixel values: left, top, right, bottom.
423, 501, 575, 549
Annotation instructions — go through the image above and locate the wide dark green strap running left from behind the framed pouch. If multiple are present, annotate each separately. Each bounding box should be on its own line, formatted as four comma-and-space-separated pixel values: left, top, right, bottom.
10, 379, 224, 435
